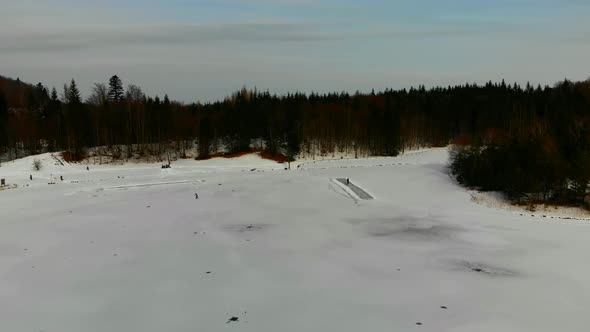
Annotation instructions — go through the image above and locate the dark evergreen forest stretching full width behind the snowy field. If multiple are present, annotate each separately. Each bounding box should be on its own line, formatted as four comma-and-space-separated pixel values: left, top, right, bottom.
0, 75, 590, 202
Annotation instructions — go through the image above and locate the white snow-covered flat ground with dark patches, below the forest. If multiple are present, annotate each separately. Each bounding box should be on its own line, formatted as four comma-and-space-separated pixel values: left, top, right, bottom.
0, 149, 590, 332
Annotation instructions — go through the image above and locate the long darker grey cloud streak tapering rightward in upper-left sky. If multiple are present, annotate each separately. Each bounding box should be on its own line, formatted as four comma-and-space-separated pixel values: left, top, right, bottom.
0, 23, 346, 52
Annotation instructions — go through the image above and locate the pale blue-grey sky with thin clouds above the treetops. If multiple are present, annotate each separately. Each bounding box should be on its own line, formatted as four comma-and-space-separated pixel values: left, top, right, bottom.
0, 0, 590, 102
